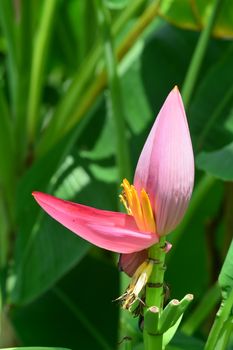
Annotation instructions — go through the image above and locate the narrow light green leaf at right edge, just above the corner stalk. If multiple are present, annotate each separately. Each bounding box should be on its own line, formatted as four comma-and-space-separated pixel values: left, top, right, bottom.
218, 240, 233, 300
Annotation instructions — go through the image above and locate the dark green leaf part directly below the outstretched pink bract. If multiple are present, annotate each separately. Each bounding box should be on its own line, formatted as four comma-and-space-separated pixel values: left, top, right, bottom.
11, 215, 90, 304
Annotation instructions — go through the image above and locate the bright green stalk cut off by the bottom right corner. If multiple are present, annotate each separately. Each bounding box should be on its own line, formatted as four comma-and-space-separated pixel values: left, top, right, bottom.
204, 289, 233, 350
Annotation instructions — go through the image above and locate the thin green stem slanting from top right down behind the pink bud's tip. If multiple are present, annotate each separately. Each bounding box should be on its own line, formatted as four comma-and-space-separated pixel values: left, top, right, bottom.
182, 0, 223, 106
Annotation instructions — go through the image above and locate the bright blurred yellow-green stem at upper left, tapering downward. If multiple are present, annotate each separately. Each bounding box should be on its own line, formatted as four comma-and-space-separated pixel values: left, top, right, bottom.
28, 0, 58, 141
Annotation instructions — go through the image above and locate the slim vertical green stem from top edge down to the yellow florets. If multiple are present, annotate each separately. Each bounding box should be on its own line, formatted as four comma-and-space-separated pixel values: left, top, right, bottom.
96, 0, 130, 182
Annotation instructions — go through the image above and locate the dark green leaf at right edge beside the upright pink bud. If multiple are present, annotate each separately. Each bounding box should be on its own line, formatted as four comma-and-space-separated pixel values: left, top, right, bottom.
196, 143, 233, 181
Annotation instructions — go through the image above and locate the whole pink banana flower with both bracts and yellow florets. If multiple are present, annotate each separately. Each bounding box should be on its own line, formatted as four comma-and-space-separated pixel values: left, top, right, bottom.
33, 87, 194, 308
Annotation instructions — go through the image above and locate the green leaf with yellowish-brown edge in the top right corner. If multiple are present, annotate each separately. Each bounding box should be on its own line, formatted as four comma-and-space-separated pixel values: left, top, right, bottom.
160, 0, 233, 38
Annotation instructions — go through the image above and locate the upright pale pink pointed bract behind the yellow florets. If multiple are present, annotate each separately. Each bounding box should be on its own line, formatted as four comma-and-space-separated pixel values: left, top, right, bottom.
134, 87, 194, 235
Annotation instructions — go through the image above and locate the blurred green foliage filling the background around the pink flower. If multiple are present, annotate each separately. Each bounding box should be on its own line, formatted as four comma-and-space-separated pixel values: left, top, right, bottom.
0, 0, 233, 350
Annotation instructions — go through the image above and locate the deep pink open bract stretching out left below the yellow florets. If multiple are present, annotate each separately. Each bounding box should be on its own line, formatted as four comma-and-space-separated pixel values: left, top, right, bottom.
33, 192, 158, 253
